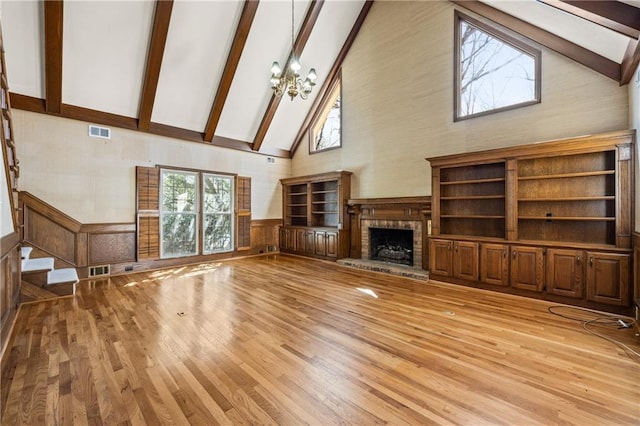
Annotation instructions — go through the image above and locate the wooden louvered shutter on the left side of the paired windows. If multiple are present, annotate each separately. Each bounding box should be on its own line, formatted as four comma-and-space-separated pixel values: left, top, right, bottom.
136, 166, 160, 261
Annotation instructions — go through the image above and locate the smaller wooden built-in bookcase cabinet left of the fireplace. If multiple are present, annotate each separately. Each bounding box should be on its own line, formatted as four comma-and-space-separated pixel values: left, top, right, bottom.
280, 171, 351, 259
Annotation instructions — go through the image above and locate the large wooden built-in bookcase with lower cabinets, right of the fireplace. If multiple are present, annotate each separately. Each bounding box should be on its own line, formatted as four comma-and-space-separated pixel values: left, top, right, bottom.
428, 131, 635, 309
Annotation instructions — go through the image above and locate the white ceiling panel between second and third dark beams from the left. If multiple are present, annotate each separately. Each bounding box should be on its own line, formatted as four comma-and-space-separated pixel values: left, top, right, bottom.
151, 0, 242, 132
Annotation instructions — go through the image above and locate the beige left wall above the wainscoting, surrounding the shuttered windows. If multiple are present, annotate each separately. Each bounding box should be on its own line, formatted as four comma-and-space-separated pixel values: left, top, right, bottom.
13, 110, 291, 223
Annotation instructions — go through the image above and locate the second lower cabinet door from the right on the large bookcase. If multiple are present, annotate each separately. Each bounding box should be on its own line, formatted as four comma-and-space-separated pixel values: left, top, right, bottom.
545, 249, 584, 297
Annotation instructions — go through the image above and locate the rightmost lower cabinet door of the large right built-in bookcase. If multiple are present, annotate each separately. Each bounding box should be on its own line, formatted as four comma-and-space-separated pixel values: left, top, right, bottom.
587, 252, 629, 306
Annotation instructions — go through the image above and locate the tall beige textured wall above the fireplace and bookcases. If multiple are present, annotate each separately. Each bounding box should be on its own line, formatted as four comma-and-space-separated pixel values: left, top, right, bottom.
292, 2, 629, 197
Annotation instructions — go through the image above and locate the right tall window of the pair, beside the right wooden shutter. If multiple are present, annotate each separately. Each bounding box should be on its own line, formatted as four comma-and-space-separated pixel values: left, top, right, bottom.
202, 174, 233, 254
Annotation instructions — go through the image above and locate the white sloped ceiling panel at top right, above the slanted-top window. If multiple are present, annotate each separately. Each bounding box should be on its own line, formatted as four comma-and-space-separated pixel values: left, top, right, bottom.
482, 0, 629, 63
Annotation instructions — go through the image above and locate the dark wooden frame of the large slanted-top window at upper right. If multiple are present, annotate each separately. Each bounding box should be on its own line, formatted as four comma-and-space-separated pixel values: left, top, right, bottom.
453, 10, 542, 122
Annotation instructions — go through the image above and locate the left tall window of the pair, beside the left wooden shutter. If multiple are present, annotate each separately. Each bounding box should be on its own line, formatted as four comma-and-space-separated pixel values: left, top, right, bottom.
160, 170, 198, 258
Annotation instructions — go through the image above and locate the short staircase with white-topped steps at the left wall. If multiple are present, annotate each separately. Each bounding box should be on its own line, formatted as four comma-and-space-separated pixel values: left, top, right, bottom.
21, 246, 78, 301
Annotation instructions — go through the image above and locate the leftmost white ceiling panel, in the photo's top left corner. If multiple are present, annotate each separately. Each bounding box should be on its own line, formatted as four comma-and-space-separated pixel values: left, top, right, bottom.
2, 1, 44, 98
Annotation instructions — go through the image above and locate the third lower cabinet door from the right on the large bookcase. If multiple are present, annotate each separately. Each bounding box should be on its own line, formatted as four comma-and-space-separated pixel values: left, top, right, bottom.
510, 246, 544, 291
